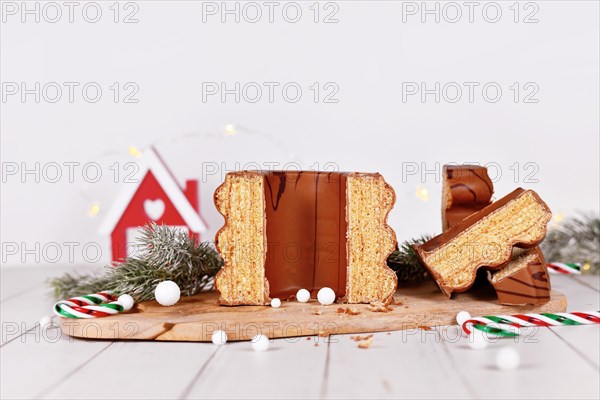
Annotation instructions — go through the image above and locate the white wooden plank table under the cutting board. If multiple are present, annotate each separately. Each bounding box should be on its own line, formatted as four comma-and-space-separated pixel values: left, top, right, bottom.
0, 267, 600, 399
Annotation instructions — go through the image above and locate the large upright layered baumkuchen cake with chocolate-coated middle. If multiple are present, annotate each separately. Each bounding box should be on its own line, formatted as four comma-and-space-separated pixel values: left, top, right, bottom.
215, 171, 397, 305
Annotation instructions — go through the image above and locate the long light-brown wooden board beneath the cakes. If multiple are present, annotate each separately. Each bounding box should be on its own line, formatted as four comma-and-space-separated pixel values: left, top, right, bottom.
60, 282, 567, 342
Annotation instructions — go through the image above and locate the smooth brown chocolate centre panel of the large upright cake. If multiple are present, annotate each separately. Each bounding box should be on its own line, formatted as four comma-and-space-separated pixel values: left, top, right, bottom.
264, 171, 347, 298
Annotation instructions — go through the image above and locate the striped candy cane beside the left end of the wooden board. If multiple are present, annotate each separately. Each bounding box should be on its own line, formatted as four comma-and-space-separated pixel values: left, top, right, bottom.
54, 291, 125, 318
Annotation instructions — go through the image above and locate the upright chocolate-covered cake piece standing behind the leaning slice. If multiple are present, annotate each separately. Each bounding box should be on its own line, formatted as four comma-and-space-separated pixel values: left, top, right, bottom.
442, 165, 494, 230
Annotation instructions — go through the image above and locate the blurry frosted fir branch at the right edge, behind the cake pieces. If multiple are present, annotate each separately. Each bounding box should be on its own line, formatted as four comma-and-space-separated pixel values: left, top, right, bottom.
541, 213, 600, 274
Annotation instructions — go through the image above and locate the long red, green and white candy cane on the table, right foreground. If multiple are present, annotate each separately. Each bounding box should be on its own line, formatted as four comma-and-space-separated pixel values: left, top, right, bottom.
462, 311, 600, 337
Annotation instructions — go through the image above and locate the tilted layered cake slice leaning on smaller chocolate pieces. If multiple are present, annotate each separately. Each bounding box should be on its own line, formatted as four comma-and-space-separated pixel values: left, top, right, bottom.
415, 188, 552, 296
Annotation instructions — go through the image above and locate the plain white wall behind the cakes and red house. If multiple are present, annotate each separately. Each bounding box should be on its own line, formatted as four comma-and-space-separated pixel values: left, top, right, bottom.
0, 1, 600, 265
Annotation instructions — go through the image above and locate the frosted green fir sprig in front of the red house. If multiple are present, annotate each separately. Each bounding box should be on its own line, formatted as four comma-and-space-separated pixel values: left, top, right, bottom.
49, 223, 223, 301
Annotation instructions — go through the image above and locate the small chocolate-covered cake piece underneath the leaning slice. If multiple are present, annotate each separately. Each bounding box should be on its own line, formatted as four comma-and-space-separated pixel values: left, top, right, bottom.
490, 246, 550, 305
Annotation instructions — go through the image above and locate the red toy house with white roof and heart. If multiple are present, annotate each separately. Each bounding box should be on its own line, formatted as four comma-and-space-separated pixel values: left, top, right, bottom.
100, 148, 207, 261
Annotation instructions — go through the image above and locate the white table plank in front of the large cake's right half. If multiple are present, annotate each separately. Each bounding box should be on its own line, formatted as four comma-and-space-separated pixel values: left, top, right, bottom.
323, 329, 474, 399
